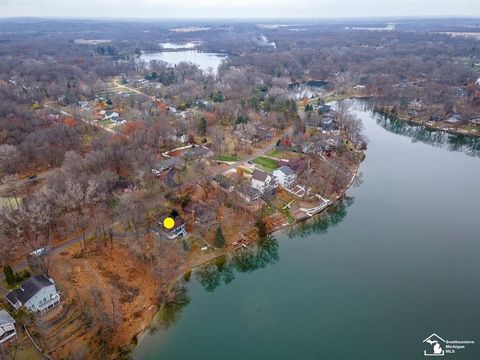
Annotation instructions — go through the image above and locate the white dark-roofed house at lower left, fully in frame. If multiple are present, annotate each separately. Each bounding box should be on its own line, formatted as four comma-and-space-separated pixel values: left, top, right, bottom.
5, 275, 60, 312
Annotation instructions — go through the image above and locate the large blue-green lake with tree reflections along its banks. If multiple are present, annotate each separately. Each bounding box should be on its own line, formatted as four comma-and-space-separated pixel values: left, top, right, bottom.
133, 102, 480, 360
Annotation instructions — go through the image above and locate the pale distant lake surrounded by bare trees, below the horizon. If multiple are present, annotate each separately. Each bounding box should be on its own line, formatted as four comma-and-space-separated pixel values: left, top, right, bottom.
139, 50, 227, 73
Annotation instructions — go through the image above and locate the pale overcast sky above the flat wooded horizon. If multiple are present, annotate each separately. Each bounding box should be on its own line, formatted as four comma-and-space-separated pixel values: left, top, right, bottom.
0, 0, 480, 18
